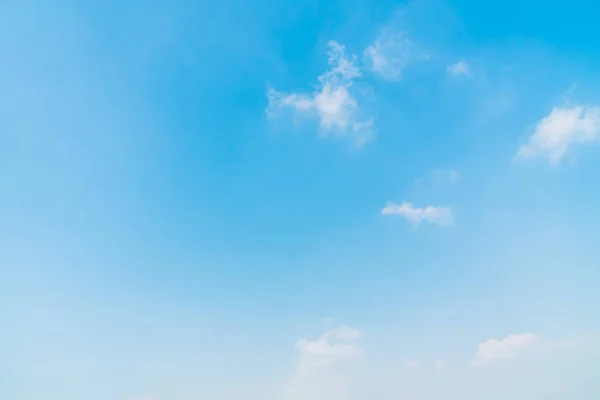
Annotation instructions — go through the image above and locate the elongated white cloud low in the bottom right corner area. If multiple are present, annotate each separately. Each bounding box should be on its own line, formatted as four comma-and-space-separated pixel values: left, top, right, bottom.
472, 333, 541, 366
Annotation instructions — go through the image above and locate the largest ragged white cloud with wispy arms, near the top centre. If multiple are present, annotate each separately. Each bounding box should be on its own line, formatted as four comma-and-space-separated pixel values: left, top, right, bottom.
267, 40, 374, 147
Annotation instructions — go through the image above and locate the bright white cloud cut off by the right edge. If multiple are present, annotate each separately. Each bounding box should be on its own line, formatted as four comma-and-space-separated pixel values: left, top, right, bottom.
517, 107, 600, 164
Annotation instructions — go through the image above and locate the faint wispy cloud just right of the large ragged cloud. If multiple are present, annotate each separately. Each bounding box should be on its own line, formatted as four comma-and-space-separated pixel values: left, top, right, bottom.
364, 30, 416, 80
